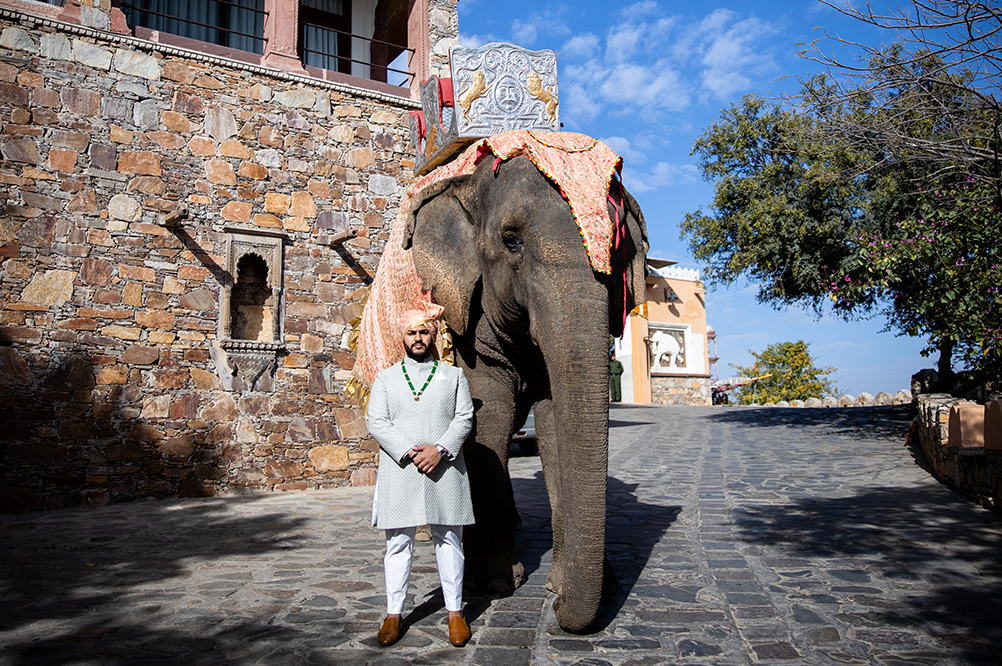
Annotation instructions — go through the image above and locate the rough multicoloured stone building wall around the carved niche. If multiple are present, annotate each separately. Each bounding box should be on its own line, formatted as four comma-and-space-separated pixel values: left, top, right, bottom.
0, 15, 426, 511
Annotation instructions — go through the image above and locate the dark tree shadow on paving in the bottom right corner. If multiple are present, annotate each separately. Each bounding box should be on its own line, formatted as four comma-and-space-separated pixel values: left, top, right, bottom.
735, 486, 1002, 664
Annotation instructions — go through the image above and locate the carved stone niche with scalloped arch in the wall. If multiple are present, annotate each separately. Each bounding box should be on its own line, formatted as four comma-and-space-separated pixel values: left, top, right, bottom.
210, 227, 287, 392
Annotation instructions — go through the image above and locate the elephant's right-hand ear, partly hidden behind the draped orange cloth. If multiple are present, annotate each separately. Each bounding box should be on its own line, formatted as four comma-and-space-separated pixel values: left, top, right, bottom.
609, 183, 650, 337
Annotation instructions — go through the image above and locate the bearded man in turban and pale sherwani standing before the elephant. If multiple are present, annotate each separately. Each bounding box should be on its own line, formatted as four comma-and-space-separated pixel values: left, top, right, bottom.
369, 310, 474, 647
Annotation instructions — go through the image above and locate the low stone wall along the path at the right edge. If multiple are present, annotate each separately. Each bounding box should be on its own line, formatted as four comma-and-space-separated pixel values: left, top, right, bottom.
913, 394, 1002, 513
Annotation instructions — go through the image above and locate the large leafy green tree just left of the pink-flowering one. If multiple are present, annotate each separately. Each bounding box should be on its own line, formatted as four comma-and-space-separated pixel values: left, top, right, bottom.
680, 95, 873, 311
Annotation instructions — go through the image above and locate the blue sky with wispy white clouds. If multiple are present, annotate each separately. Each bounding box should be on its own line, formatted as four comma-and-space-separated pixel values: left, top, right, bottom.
459, 0, 936, 396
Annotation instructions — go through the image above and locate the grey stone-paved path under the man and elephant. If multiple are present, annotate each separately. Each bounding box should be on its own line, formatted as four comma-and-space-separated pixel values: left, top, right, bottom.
0, 406, 1002, 666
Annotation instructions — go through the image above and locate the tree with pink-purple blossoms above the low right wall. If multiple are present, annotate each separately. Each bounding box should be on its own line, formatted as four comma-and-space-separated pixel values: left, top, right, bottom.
832, 177, 1002, 384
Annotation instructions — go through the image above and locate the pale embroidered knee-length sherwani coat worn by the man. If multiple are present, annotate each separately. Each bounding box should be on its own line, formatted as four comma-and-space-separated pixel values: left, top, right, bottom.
369, 357, 474, 530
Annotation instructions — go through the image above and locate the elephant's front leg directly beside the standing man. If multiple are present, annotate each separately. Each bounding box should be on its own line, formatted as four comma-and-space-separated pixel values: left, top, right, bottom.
463, 372, 525, 593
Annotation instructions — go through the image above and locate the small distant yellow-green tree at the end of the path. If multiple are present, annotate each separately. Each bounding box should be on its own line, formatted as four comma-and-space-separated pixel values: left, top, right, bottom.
731, 341, 839, 405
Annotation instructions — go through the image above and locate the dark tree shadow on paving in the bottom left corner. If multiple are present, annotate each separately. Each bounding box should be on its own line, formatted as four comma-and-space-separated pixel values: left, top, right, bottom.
0, 497, 356, 664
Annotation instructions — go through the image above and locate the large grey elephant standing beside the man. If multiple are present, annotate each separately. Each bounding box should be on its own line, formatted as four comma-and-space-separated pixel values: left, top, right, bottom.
403, 148, 648, 633
